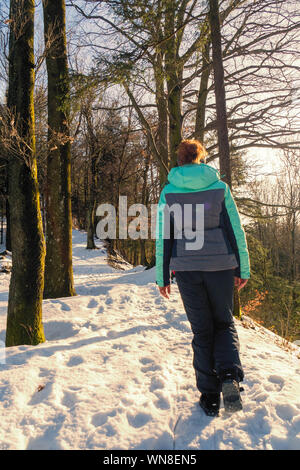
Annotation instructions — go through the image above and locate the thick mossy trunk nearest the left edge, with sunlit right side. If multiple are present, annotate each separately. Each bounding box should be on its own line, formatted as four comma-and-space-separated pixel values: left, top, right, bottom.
6, 0, 45, 346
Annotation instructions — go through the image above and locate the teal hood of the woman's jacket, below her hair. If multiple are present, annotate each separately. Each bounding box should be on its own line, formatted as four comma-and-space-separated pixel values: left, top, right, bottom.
168, 163, 220, 189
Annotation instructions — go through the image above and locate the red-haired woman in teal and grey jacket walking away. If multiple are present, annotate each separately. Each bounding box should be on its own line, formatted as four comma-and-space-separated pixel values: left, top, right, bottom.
156, 140, 250, 416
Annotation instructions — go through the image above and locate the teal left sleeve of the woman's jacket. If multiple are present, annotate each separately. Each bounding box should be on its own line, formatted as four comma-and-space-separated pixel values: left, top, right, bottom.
155, 188, 174, 287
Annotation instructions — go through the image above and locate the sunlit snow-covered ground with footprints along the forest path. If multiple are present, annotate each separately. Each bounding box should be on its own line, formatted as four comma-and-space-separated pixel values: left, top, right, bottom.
0, 231, 300, 450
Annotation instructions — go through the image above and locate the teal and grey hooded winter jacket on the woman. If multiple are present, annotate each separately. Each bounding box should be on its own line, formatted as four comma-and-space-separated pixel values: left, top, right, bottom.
156, 163, 250, 286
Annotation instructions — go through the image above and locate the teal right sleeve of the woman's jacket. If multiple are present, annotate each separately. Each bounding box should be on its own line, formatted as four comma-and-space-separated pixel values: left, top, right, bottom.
224, 185, 250, 279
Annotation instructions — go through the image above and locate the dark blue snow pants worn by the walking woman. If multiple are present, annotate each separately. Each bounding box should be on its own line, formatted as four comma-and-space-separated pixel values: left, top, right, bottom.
175, 269, 244, 393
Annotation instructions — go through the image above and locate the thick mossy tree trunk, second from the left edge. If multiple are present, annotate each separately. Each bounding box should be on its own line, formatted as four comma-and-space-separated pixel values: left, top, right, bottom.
43, 0, 76, 298
